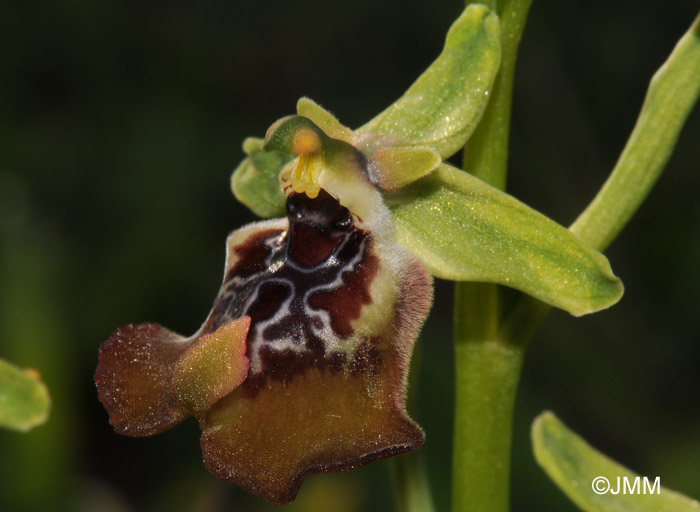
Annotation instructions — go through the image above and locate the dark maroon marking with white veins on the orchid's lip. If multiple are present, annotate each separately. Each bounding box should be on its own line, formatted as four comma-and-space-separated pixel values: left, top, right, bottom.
208, 190, 381, 391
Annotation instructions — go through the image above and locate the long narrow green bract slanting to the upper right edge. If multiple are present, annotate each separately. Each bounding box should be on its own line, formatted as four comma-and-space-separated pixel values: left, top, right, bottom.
571, 11, 700, 250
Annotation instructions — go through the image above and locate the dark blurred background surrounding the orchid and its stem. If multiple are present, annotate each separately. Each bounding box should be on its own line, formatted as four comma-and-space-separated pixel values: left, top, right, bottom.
0, 0, 700, 512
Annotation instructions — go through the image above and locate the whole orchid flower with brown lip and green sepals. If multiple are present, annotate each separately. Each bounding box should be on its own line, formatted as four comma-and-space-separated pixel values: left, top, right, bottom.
95, 5, 622, 503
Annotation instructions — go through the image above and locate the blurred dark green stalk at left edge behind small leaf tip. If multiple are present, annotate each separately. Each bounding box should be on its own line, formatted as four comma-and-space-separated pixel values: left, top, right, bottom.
0, 230, 75, 512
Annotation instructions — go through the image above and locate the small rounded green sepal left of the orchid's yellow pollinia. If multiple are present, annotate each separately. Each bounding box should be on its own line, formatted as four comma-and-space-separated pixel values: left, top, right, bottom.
231, 137, 295, 218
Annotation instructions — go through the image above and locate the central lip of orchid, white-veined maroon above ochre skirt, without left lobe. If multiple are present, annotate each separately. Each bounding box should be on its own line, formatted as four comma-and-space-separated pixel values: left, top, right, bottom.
200, 185, 432, 504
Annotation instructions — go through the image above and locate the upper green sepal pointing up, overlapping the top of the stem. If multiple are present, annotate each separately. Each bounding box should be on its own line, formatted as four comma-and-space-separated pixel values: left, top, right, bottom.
357, 4, 501, 158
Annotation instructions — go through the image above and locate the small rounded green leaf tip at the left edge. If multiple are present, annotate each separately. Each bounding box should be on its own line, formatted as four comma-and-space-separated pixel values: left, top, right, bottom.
0, 359, 51, 432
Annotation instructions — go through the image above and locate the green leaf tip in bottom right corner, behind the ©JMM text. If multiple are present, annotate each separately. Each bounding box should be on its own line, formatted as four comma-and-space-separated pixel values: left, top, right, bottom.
532, 412, 700, 512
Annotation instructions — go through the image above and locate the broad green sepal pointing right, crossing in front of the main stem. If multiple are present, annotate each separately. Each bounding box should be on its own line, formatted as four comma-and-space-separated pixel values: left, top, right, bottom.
387, 164, 623, 316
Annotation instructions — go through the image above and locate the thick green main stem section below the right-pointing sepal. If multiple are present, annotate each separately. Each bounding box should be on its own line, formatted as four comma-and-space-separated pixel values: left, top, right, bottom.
452, 283, 525, 512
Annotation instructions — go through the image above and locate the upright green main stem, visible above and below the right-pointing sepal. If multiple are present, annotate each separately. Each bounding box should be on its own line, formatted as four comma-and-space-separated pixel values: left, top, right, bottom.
452, 0, 531, 512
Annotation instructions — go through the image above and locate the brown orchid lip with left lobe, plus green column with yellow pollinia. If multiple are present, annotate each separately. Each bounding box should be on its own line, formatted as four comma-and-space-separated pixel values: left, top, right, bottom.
95, 116, 432, 503
